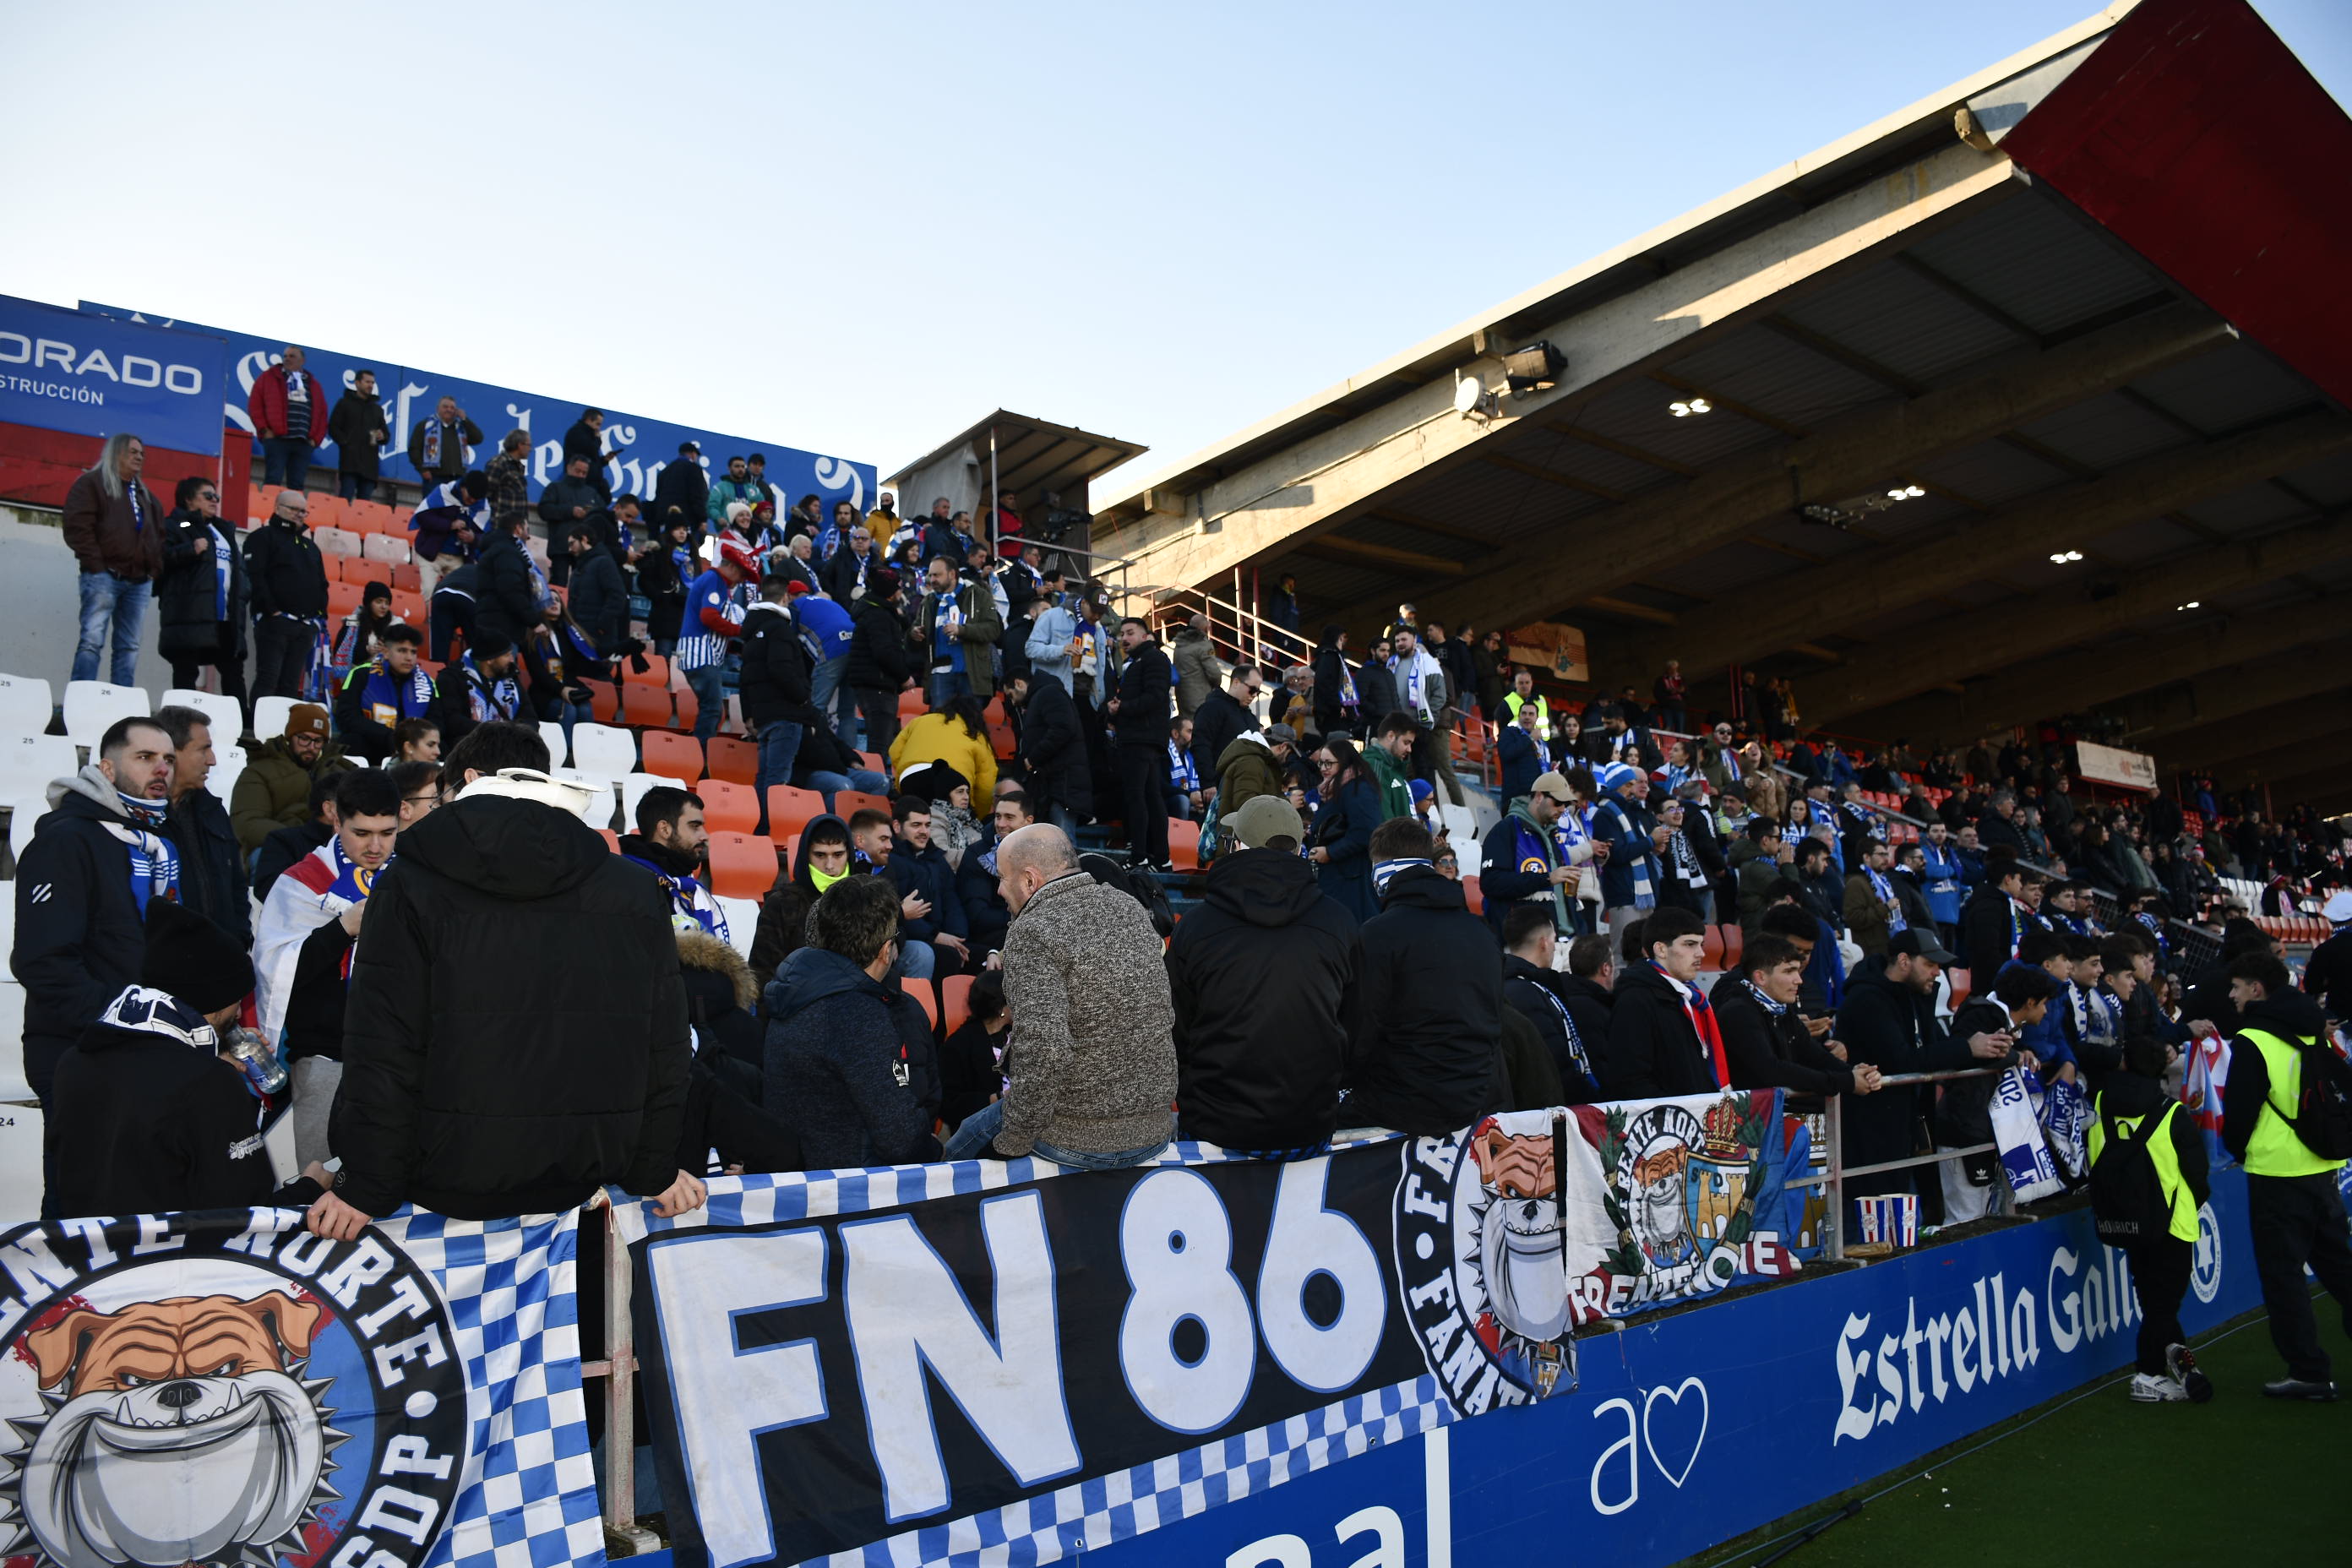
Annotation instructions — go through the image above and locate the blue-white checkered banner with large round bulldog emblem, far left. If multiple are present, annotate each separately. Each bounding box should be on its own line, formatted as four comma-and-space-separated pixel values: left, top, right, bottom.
0, 1208, 604, 1568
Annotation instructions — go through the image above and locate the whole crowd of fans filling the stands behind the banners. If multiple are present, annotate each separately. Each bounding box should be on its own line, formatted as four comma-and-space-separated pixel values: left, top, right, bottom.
12, 409, 2352, 1401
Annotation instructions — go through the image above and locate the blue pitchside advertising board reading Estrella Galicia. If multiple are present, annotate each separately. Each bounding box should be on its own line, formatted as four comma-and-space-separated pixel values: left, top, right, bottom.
1084, 1168, 2260, 1568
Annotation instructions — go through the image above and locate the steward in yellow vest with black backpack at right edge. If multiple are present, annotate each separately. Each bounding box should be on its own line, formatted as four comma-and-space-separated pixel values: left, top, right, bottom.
2220, 947, 2352, 1401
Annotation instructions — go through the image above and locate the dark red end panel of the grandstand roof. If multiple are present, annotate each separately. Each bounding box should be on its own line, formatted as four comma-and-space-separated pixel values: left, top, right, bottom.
2001, 0, 2352, 405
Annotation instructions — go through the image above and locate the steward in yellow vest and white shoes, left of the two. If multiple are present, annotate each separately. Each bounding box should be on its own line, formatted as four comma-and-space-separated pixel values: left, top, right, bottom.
2091, 1034, 2213, 1403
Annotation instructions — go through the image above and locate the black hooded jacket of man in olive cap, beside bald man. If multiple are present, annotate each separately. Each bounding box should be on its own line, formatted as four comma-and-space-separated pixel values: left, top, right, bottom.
1167, 849, 1364, 1152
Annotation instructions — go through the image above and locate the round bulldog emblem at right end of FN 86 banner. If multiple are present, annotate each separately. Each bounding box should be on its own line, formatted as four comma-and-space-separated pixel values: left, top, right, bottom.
1397, 1117, 1576, 1415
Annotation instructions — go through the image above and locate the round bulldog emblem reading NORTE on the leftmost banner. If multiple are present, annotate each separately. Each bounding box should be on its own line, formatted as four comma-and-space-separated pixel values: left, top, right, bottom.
0, 1208, 468, 1568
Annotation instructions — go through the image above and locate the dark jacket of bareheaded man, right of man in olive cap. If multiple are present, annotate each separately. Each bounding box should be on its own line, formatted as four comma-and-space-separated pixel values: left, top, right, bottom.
1345, 865, 1510, 1135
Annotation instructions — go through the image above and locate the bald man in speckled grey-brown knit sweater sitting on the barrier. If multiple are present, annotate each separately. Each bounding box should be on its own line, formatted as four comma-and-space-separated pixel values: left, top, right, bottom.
948, 823, 1176, 1171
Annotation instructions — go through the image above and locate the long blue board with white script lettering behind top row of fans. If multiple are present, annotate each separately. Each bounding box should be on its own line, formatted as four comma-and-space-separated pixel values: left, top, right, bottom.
83, 298, 875, 513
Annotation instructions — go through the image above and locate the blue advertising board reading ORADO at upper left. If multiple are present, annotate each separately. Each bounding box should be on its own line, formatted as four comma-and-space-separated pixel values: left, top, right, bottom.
0, 297, 228, 456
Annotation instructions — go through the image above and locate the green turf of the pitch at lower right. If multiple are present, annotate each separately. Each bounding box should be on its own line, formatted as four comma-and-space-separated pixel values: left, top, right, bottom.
1689, 1300, 2352, 1568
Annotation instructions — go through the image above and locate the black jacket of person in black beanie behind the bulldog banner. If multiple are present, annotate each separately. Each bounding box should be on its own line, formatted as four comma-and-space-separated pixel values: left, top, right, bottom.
47, 997, 318, 1216
